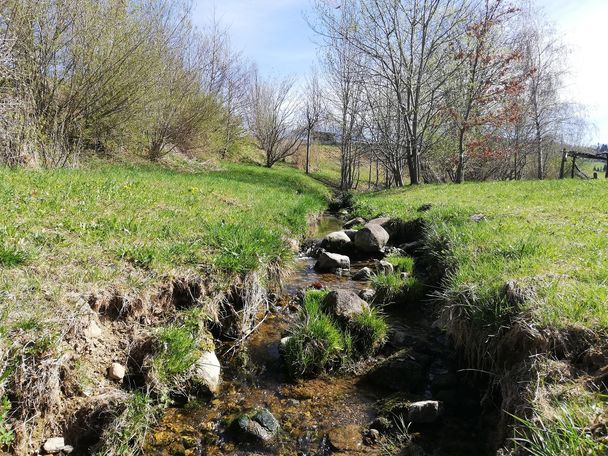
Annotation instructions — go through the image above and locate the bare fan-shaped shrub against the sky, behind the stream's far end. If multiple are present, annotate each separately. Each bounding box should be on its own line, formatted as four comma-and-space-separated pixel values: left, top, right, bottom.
247, 72, 304, 168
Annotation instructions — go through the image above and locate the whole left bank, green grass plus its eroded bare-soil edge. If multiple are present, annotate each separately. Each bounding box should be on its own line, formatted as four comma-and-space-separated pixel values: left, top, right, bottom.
0, 160, 328, 454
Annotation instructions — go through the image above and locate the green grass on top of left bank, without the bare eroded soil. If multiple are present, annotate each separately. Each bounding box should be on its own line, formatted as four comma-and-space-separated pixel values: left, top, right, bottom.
0, 160, 328, 324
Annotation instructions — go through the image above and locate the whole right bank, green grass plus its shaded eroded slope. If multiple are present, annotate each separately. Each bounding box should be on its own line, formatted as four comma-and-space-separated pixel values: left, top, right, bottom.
356, 180, 608, 455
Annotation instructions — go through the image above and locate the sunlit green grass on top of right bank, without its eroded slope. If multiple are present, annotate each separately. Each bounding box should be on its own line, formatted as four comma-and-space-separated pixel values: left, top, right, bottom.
356, 180, 608, 330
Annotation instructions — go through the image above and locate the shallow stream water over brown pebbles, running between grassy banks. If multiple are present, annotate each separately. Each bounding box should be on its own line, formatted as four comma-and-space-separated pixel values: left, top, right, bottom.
145, 215, 491, 456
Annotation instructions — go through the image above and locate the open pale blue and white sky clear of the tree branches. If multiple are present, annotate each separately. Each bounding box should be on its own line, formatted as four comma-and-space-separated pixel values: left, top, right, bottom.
194, 0, 608, 143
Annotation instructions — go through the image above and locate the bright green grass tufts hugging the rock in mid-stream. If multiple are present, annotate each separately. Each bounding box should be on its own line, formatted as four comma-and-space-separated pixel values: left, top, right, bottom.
282, 290, 388, 378
